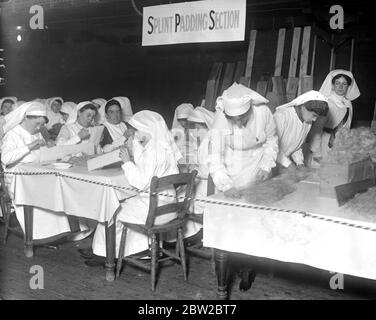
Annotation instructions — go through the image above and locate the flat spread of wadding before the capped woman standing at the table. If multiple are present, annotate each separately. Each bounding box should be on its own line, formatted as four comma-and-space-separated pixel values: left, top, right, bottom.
225, 168, 312, 205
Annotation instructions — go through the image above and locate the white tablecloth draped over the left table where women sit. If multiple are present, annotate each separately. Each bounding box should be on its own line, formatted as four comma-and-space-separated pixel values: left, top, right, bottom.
10, 164, 136, 224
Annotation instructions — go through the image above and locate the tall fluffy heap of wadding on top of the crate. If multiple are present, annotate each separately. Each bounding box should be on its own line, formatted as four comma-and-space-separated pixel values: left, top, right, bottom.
323, 127, 376, 164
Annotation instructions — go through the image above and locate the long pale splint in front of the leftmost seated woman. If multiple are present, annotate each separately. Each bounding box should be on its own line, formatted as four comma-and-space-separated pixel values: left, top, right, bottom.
39, 142, 95, 162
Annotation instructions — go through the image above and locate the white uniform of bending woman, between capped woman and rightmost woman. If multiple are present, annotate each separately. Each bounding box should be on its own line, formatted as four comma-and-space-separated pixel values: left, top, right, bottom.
273, 108, 312, 168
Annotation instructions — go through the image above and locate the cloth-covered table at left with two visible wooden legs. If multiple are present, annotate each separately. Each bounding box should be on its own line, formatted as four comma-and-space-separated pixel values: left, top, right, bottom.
5, 164, 137, 281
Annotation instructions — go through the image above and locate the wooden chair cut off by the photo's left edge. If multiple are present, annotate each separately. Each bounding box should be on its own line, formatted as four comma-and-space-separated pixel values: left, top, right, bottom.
0, 161, 20, 244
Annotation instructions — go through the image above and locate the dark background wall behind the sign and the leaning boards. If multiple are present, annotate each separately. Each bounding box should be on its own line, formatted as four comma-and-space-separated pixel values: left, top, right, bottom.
0, 1, 376, 127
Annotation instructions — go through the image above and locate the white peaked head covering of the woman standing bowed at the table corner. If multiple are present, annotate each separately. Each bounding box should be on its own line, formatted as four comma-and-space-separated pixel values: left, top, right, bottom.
213, 82, 269, 131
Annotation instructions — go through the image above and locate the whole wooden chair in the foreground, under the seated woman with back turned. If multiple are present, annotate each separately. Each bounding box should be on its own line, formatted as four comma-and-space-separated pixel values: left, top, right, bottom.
116, 170, 197, 291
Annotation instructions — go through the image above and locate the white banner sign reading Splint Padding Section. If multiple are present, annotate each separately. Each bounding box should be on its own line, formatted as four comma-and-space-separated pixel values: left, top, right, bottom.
142, 0, 247, 46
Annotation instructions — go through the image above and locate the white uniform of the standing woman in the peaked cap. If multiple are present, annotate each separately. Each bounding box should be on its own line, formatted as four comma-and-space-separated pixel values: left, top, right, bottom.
208, 105, 278, 191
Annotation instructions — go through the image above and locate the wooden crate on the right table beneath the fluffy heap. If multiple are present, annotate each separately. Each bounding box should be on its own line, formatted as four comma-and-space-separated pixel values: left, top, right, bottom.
319, 158, 375, 198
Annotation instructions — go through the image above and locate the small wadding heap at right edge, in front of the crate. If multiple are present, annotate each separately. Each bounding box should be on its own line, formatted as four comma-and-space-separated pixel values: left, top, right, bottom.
343, 187, 376, 222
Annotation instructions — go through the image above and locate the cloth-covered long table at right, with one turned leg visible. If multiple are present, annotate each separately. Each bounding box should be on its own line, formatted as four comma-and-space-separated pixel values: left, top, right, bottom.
203, 181, 376, 299
